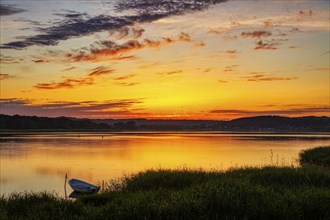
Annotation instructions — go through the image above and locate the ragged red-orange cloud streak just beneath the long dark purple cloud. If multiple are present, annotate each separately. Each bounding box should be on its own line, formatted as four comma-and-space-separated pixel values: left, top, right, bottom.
66, 32, 191, 62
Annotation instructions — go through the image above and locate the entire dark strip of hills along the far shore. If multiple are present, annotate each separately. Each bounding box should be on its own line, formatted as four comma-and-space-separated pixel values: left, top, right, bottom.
0, 115, 330, 132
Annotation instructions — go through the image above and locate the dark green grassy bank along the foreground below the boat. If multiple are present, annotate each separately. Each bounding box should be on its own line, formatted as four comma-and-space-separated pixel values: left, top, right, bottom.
0, 166, 330, 220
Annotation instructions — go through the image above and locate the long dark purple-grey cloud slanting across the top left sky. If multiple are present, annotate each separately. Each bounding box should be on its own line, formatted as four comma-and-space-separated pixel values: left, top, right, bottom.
1, 0, 226, 49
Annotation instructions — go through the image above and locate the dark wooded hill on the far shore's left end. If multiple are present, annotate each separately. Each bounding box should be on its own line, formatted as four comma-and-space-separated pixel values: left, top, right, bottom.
0, 115, 111, 130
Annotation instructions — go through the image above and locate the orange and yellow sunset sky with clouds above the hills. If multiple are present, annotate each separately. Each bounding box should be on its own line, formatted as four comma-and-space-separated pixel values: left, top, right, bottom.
0, 0, 330, 120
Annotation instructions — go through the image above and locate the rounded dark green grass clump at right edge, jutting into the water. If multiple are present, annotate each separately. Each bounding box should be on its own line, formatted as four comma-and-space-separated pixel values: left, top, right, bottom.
299, 146, 330, 167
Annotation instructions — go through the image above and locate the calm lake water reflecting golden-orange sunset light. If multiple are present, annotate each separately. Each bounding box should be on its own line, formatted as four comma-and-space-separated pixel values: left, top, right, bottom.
0, 133, 330, 195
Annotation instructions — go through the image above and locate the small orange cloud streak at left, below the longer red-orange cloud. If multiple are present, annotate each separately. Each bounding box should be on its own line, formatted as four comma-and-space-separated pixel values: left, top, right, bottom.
34, 66, 114, 90
